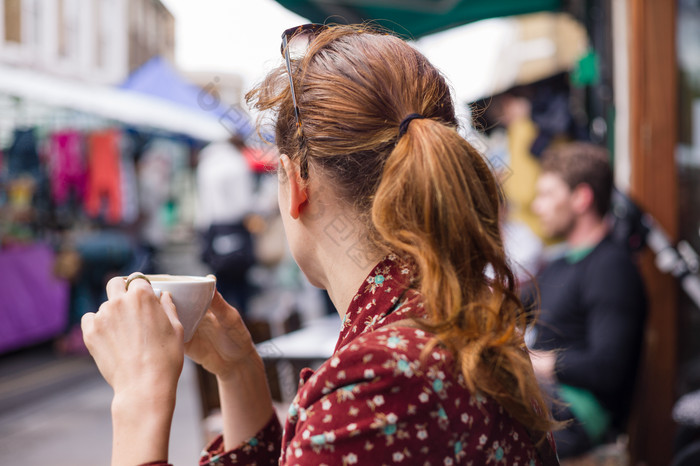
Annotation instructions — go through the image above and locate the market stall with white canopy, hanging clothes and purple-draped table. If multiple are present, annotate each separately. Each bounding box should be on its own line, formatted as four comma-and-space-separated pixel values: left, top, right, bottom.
0, 60, 250, 354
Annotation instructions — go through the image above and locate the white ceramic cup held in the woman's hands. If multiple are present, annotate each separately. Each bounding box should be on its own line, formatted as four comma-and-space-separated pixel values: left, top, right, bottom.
127, 274, 216, 342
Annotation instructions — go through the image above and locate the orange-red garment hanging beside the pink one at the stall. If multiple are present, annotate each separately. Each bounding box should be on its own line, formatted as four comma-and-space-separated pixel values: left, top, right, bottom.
85, 129, 122, 224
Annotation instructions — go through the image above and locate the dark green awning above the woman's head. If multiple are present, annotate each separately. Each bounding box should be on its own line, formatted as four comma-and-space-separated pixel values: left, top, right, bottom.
277, 0, 561, 38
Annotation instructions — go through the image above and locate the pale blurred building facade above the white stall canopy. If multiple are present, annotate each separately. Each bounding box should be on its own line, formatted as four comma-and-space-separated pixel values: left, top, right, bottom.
0, 0, 175, 84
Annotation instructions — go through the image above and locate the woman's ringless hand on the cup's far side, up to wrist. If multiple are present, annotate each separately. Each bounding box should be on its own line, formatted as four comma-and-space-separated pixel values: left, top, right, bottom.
185, 291, 259, 380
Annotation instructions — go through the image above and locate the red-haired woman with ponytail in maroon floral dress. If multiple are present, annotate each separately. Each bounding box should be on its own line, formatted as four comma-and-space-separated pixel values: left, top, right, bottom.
83, 25, 557, 465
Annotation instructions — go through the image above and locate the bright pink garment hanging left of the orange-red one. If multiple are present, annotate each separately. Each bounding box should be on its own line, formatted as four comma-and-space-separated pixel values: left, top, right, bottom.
48, 130, 87, 205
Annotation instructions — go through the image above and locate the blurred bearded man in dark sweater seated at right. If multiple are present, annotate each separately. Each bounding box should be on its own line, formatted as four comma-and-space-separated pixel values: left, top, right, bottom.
528, 142, 646, 458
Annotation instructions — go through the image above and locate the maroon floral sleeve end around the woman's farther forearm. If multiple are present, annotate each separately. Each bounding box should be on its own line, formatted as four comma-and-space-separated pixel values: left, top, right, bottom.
197, 413, 282, 466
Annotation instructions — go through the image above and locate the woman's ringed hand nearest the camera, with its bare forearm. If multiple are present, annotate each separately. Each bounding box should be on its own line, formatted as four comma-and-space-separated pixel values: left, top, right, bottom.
81, 277, 184, 466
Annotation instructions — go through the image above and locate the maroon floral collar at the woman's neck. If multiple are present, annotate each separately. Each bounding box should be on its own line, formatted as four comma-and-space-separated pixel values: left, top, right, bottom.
334, 254, 422, 352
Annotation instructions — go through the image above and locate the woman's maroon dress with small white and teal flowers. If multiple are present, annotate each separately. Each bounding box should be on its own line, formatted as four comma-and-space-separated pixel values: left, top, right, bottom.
152, 255, 556, 466
